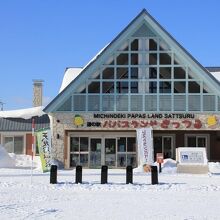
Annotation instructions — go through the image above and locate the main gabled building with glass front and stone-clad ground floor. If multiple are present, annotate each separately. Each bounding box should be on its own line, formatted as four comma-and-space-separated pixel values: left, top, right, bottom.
44, 10, 220, 168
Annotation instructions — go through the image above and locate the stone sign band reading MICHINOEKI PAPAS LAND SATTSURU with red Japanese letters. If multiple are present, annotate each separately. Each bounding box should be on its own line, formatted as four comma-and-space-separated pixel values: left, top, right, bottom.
67, 113, 220, 130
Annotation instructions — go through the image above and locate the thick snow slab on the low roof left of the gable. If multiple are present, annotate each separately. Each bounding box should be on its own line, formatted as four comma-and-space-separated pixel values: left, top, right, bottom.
0, 106, 46, 119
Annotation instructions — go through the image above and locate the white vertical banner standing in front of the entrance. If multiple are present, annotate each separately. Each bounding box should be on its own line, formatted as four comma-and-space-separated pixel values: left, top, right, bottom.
137, 128, 154, 167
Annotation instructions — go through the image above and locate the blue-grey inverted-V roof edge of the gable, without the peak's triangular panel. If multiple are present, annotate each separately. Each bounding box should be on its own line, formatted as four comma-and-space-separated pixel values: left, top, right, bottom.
44, 9, 220, 113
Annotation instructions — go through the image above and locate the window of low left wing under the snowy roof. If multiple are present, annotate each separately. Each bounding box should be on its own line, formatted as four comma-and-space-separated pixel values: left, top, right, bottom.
4, 136, 25, 154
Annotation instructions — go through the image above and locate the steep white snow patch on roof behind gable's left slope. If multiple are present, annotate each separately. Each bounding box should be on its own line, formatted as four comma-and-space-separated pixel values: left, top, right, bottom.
59, 68, 82, 93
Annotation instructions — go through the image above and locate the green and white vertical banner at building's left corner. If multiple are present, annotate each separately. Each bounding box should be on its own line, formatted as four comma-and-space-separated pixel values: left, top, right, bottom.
37, 129, 51, 172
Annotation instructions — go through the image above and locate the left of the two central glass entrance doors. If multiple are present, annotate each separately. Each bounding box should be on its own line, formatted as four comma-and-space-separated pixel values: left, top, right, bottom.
90, 138, 102, 168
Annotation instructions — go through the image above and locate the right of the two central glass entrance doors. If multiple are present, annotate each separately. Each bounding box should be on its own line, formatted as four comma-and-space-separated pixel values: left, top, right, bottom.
105, 138, 116, 167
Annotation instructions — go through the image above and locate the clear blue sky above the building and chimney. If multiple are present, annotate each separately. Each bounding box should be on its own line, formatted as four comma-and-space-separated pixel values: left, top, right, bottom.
0, 0, 220, 110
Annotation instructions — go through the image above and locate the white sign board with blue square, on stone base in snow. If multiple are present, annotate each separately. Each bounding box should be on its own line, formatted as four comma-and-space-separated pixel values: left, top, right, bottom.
177, 147, 207, 165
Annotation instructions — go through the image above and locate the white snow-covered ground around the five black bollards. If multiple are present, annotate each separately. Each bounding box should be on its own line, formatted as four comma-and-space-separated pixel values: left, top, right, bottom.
0, 145, 220, 220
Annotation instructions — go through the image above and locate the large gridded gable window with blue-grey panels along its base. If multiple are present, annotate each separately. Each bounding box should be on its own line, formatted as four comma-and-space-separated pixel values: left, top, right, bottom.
69, 34, 220, 112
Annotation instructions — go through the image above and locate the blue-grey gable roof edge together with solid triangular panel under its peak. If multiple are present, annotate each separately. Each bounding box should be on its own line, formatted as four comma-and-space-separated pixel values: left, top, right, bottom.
44, 9, 220, 112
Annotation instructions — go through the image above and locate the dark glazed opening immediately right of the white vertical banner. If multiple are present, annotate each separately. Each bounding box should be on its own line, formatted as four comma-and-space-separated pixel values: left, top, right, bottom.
154, 136, 173, 160
